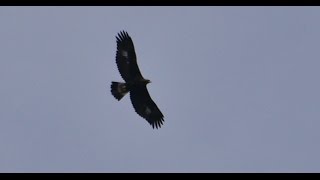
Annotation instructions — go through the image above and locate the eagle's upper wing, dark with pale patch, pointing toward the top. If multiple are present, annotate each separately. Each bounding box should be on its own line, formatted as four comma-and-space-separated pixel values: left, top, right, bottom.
116, 31, 142, 82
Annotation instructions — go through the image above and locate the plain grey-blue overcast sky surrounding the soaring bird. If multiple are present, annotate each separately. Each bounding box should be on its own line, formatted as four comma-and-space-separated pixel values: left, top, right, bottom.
0, 7, 320, 172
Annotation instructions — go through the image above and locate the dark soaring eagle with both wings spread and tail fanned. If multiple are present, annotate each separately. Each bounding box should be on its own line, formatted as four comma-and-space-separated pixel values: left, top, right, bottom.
111, 31, 164, 129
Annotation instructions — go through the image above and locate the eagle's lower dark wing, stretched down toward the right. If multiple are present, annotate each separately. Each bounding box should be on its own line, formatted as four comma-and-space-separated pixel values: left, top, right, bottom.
130, 85, 164, 129
